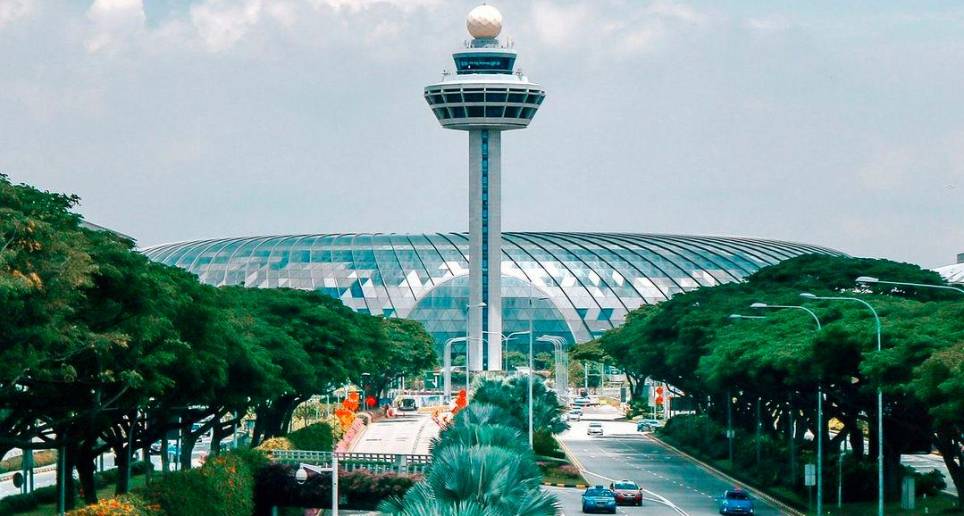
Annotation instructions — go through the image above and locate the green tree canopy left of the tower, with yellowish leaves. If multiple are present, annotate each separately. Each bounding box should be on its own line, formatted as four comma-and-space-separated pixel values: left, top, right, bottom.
0, 175, 436, 501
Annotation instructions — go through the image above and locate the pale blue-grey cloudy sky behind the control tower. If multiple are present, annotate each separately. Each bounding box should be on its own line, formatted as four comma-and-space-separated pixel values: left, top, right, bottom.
0, 0, 964, 267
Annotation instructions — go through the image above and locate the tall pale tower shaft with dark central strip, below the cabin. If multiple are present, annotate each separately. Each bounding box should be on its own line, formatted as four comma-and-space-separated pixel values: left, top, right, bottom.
469, 128, 502, 371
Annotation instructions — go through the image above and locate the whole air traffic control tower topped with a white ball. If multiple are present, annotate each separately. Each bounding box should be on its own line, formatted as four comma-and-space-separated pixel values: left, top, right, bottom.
425, 5, 546, 371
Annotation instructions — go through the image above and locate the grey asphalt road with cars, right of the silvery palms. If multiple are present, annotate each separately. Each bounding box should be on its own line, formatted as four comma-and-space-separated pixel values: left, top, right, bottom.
553, 407, 781, 515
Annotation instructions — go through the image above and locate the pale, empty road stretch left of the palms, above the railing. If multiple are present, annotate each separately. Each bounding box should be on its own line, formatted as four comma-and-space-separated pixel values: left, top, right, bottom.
351, 414, 439, 455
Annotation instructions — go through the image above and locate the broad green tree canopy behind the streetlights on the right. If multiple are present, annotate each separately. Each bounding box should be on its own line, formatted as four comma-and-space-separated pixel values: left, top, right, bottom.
596, 255, 964, 504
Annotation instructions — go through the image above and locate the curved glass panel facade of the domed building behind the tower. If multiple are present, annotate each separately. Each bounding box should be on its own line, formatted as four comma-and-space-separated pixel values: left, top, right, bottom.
143, 232, 840, 349
